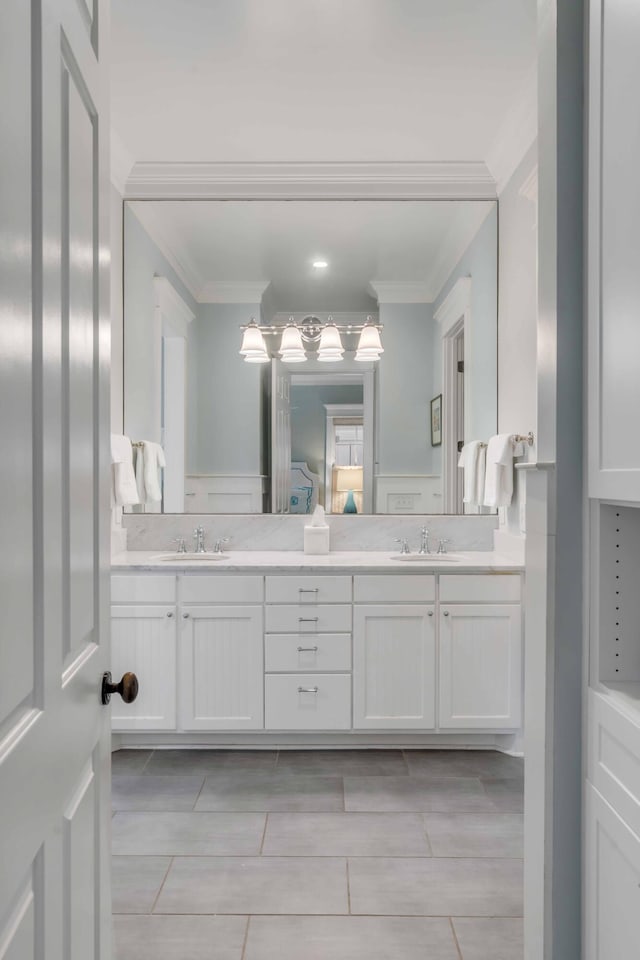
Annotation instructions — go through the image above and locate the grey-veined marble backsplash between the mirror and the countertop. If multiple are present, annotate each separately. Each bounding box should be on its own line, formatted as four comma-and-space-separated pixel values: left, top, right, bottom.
122, 514, 498, 552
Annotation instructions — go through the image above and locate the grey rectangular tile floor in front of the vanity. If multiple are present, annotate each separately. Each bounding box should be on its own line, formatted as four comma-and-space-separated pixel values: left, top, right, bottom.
113, 750, 523, 960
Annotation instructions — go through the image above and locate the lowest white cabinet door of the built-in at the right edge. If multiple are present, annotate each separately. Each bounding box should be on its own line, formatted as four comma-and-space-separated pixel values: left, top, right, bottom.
585, 783, 640, 960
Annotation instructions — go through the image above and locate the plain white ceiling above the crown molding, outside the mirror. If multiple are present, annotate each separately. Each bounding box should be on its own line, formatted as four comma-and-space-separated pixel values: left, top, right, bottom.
111, 0, 536, 179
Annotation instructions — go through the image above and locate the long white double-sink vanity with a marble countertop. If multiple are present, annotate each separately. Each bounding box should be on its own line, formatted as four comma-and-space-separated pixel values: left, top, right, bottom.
112, 551, 523, 745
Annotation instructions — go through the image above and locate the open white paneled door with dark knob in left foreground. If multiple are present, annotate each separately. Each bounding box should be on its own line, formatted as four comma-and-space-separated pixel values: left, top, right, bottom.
0, 0, 110, 960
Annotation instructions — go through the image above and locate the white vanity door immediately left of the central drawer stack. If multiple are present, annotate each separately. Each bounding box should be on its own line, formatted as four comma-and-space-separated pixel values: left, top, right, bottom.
180, 607, 264, 730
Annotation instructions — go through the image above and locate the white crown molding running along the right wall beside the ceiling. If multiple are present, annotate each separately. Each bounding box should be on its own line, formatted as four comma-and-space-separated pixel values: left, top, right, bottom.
487, 70, 538, 195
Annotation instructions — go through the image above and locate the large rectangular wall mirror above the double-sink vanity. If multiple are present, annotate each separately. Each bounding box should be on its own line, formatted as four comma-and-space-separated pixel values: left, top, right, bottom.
124, 200, 498, 514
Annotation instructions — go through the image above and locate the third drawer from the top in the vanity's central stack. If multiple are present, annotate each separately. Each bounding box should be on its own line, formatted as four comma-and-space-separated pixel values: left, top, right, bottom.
264, 633, 351, 673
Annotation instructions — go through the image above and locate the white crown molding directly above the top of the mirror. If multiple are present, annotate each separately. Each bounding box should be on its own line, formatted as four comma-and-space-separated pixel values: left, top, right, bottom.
125, 161, 496, 200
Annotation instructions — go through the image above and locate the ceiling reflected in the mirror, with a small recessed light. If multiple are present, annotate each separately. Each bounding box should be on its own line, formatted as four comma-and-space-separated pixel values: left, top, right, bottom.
125, 200, 495, 312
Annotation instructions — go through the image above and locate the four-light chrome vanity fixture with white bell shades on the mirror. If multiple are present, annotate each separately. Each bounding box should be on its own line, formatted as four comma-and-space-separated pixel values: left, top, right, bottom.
240, 315, 384, 363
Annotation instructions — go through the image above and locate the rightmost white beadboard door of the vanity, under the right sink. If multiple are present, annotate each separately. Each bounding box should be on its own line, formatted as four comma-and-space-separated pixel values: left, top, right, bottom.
440, 603, 522, 730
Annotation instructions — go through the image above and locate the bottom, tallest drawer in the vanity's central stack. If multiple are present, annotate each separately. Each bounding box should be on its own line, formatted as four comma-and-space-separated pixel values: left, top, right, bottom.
264, 673, 351, 730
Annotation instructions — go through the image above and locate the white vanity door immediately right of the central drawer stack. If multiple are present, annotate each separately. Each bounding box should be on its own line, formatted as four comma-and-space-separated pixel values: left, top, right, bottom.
353, 604, 435, 730
